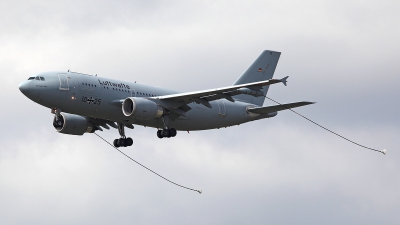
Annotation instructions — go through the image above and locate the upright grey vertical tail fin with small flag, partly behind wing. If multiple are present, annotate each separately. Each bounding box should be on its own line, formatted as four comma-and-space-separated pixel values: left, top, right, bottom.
234, 50, 281, 106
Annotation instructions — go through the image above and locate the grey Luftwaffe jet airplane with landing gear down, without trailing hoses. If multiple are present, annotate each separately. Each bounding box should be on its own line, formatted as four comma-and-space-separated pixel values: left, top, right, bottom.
19, 50, 314, 148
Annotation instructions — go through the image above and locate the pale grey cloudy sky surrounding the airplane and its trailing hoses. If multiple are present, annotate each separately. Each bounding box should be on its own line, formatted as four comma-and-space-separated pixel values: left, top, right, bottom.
0, 0, 400, 224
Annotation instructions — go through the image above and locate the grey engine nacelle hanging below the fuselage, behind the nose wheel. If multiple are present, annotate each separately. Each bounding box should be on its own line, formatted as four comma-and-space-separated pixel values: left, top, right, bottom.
53, 113, 95, 135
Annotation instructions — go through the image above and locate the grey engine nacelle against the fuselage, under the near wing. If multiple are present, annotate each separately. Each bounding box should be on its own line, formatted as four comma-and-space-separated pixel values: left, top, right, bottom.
122, 97, 164, 120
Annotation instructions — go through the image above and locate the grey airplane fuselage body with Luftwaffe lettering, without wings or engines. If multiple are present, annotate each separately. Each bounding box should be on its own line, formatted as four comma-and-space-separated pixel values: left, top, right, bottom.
20, 72, 277, 131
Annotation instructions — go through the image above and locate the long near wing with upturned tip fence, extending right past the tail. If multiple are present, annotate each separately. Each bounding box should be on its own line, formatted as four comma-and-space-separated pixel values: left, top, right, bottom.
151, 77, 288, 108
